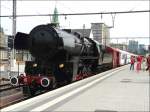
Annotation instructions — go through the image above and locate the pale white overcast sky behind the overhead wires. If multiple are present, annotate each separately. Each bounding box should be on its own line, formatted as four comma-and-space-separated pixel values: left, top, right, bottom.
1, 0, 150, 45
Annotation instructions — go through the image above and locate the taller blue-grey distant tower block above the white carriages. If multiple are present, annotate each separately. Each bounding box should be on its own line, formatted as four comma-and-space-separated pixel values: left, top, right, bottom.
128, 40, 138, 54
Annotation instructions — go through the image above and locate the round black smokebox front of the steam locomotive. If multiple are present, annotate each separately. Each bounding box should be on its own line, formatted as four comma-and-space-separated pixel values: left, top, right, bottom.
29, 25, 60, 59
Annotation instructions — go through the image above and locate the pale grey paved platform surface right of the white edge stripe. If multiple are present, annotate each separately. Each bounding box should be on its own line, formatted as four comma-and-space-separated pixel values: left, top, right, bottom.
52, 66, 150, 112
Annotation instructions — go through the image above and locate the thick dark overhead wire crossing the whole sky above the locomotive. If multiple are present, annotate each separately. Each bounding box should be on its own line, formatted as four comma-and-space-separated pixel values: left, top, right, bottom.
0, 10, 150, 17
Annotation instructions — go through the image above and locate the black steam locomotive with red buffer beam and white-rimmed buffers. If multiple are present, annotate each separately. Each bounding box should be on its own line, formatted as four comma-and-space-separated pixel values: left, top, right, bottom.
11, 24, 104, 95
